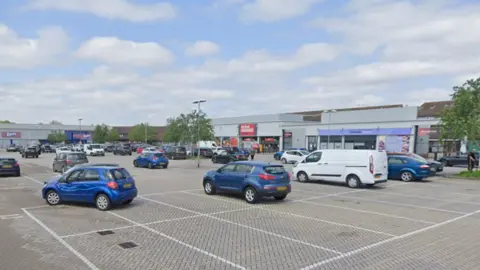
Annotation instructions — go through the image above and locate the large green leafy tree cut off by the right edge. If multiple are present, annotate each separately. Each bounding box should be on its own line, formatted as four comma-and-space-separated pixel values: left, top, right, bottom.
440, 78, 480, 150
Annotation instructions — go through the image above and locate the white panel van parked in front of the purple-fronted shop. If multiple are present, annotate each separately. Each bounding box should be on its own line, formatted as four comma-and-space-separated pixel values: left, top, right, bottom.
293, 149, 388, 188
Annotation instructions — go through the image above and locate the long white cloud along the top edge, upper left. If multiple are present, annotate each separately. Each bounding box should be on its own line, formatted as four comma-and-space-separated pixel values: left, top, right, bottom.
27, 0, 177, 22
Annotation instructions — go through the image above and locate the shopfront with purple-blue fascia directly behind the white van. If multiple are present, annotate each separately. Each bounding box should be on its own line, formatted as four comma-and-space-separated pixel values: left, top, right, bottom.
316, 128, 412, 152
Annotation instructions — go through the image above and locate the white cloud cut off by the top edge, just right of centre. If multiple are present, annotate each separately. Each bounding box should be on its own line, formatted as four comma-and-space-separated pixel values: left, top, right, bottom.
240, 0, 321, 23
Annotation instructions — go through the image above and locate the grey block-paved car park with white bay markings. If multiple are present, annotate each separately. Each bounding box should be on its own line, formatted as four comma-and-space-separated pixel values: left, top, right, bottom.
0, 153, 480, 269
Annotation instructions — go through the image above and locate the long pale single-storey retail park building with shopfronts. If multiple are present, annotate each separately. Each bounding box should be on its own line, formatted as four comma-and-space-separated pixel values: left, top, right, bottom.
0, 101, 460, 158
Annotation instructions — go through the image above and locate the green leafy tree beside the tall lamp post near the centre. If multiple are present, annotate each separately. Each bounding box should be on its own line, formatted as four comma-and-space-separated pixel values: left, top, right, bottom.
164, 110, 215, 143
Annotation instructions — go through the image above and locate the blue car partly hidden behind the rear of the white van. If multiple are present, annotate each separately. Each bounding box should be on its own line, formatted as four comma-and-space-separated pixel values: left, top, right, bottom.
388, 155, 435, 182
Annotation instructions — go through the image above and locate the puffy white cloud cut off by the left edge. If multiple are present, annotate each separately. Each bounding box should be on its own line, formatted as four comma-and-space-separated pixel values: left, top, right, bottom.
0, 24, 68, 69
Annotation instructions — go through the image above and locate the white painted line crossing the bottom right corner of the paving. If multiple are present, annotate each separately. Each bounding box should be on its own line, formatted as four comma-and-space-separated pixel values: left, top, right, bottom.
301, 210, 480, 270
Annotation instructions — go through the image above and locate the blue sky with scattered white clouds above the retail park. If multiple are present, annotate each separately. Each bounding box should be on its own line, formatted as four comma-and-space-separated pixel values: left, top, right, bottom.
0, 0, 480, 125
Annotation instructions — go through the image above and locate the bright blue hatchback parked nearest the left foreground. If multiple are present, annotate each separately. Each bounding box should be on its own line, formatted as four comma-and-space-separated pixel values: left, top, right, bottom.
42, 166, 137, 211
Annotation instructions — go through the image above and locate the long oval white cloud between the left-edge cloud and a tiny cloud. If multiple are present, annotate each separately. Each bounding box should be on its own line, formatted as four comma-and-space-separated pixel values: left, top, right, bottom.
76, 37, 175, 67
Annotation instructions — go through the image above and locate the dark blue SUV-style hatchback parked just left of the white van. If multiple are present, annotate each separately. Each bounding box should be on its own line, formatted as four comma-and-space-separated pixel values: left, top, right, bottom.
203, 161, 292, 203
